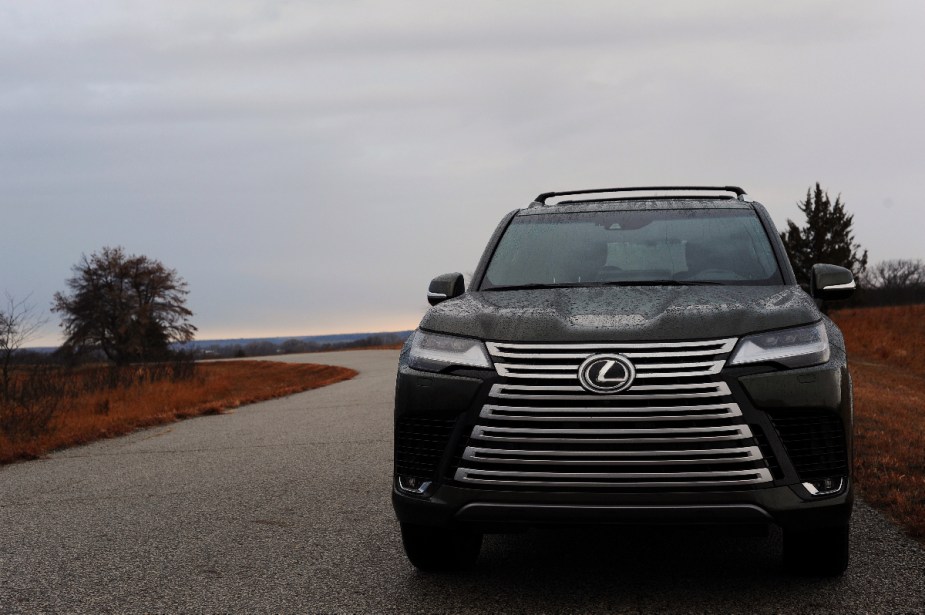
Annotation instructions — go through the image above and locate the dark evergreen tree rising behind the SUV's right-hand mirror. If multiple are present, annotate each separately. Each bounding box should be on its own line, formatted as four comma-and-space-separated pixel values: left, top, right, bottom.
780, 182, 867, 284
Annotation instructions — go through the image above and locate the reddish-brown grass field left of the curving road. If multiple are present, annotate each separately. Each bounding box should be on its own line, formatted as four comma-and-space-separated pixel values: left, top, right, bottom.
0, 361, 356, 463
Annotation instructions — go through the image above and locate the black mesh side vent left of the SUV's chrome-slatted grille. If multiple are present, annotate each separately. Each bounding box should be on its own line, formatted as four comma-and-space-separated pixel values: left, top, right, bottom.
395, 417, 456, 480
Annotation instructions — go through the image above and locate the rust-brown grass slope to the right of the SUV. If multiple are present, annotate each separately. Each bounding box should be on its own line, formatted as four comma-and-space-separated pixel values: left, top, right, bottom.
832, 305, 925, 542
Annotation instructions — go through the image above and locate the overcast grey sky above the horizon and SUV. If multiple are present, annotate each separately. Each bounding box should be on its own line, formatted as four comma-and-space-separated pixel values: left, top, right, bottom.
0, 0, 925, 344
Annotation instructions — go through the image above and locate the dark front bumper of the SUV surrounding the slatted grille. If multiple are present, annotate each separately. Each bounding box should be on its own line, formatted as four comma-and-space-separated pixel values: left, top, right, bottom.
392, 357, 853, 531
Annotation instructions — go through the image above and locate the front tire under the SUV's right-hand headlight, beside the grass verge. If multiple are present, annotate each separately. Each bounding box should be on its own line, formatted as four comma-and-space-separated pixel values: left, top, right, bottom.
784, 525, 849, 577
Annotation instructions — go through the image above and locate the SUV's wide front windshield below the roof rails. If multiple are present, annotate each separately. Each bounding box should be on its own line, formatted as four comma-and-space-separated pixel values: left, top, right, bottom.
481, 209, 783, 290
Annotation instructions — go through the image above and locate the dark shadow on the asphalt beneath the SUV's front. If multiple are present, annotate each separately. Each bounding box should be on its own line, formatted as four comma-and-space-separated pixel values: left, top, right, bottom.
392, 527, 850, 613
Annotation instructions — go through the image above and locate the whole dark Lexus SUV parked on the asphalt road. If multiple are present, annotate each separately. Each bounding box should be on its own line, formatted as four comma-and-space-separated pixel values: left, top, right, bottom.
392, 186, 855, 575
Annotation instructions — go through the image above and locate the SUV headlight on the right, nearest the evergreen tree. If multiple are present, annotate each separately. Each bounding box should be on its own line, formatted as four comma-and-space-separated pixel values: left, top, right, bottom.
729, 321, 829, 367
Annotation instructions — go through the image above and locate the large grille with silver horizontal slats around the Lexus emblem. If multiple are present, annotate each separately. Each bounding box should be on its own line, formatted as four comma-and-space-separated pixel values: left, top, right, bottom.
453, 339, 772, 490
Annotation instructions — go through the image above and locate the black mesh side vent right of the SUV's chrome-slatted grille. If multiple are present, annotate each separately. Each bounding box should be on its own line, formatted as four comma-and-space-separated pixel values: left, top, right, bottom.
768, 410, 848, 480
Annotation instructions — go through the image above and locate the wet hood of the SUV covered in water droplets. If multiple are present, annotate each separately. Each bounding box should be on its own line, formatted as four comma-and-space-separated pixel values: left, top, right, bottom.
421, 286, 821, 342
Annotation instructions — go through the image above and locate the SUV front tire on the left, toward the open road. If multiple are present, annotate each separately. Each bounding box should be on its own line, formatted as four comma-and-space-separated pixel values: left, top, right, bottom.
401, 523, 482, 572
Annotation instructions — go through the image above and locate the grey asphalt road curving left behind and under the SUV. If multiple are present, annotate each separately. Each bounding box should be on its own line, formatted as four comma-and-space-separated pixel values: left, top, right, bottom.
0, 351, 925, 613
